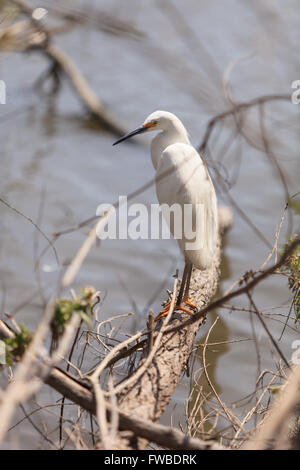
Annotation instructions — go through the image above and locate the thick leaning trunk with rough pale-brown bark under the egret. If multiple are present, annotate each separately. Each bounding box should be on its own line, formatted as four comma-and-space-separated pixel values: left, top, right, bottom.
118, 207, 232, 448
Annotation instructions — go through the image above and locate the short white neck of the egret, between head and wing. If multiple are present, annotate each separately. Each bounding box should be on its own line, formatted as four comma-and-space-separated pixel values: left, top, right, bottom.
151, 120, 190, 170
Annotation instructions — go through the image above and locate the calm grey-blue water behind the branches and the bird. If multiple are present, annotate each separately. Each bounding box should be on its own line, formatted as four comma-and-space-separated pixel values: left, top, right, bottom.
0, 0, 300, 447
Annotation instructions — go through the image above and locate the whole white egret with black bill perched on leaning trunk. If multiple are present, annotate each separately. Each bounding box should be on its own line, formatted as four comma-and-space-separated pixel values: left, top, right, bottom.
113, 111, 218, 318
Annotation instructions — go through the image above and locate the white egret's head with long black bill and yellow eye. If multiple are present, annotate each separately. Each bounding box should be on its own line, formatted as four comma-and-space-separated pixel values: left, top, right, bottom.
113, 111, 180, 145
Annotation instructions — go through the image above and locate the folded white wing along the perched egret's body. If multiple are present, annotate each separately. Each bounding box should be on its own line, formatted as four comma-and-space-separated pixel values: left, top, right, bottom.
156, 143, 217, 267
